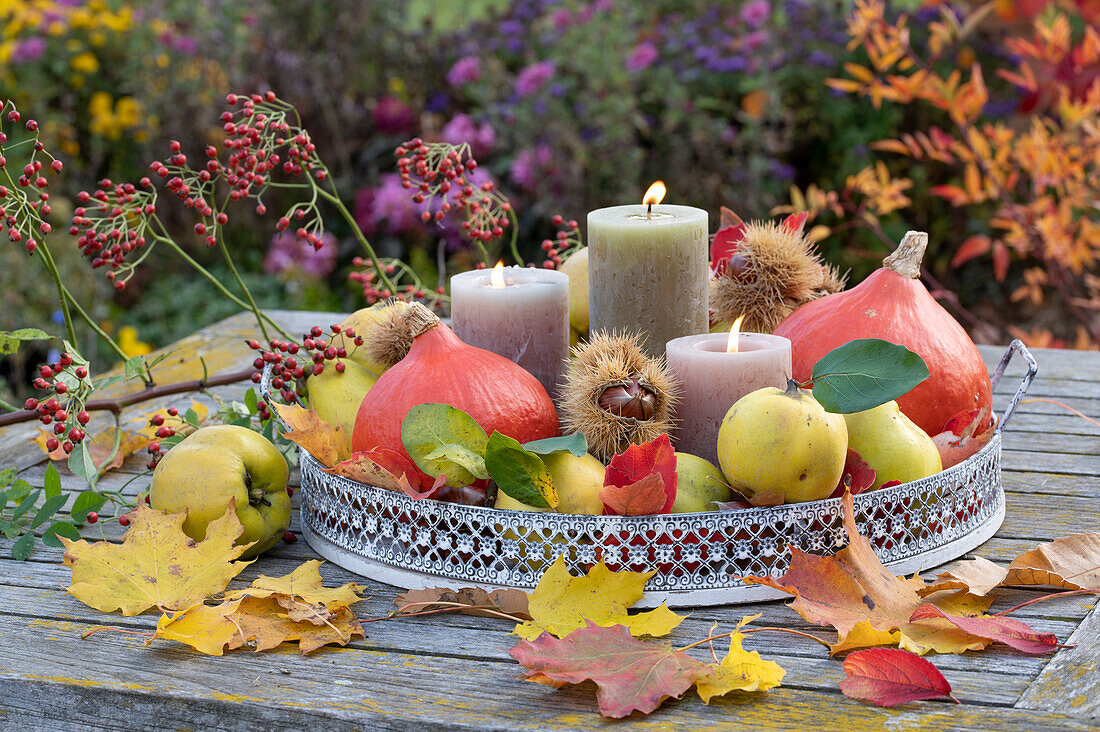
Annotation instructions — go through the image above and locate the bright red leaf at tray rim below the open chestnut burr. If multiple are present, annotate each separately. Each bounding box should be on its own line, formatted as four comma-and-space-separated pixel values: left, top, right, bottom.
600, 435, 677, 515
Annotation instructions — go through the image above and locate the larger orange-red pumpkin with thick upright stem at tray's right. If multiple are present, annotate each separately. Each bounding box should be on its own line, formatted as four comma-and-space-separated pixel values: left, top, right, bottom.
773, 231, 992, 435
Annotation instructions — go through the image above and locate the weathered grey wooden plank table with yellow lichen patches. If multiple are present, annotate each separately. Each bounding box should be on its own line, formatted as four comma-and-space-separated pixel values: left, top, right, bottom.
0, 313, 1100, 730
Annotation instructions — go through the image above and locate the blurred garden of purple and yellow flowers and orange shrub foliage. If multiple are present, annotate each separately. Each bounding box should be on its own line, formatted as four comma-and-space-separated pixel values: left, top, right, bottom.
0, 0, 1100, 396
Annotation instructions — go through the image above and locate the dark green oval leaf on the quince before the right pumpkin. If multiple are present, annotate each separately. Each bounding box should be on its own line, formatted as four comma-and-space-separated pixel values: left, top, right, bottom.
813, 338, 928, 414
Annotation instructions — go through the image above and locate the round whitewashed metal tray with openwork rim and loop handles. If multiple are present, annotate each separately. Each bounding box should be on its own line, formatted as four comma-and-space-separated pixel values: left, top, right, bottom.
261, 340, 1037, 607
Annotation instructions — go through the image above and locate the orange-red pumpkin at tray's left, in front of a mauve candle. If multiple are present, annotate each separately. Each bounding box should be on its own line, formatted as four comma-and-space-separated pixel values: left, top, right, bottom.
352, 303, 561, 485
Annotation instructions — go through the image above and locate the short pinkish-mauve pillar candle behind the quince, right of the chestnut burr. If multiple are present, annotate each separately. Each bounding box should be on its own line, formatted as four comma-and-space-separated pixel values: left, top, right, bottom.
666, 332, 791, 465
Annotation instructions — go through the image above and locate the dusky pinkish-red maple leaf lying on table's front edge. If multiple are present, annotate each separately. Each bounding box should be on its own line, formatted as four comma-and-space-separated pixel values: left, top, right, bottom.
508, 622, 708, 718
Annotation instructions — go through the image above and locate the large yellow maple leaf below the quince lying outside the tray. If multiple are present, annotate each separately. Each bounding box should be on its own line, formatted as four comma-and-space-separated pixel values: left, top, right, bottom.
62, 501, 252, 615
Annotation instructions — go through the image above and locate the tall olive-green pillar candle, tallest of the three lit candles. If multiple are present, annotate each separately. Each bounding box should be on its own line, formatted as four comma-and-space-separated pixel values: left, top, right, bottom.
589, 193, 711, 357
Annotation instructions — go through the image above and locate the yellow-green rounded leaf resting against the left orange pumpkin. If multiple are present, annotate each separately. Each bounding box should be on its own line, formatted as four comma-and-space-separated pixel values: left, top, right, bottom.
402, 404, 488, 488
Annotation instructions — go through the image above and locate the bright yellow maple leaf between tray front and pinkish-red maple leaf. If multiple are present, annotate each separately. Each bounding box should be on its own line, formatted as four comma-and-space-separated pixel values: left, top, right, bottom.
514, 556, 684, 641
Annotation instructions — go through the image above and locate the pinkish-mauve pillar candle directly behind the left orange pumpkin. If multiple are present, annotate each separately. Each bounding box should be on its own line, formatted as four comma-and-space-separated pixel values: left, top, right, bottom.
451, 266, 569, 397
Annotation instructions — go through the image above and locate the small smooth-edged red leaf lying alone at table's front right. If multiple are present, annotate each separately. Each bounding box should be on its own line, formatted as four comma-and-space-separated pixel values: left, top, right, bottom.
840, 648, 958, 707
